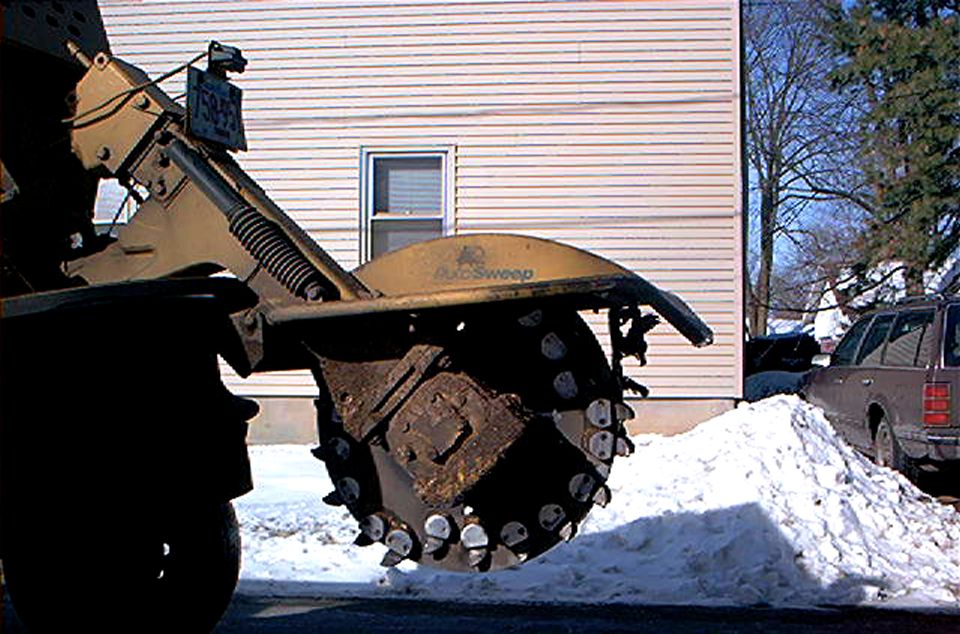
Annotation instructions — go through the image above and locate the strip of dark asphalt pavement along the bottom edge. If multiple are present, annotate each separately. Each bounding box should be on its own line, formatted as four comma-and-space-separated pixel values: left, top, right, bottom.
7, 595, 960, 634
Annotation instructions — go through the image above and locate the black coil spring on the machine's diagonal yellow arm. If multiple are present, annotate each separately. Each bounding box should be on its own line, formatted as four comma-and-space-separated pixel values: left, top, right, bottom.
230, 205, 328, 300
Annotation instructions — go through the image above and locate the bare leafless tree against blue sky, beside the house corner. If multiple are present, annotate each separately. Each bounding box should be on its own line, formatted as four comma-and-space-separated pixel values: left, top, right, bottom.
744, 0, 860, 335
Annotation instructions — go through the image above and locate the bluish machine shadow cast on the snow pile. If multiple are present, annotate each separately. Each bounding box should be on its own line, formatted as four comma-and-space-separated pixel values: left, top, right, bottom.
229, 504, 887, 607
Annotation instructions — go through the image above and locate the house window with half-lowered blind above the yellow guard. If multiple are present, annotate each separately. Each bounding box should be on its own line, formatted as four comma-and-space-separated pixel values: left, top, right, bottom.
361, 150, 450, 261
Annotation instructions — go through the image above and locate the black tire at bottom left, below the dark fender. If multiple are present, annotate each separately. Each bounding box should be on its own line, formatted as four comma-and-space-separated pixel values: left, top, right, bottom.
4, 502, 240, 634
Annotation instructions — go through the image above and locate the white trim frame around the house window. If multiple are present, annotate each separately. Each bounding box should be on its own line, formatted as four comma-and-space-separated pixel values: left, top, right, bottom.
360, 145, 456, 264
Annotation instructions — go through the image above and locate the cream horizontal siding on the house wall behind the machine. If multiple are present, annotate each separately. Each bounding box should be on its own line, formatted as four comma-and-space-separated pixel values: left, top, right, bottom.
101, 0, 743, 398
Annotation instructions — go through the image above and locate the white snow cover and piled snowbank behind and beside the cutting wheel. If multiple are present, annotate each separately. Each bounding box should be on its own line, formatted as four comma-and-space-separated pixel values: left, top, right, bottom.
237, 396, 960, 607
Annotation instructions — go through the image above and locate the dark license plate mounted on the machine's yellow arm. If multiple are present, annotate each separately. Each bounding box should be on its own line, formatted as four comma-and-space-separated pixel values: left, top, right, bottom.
187, 66, 247, 150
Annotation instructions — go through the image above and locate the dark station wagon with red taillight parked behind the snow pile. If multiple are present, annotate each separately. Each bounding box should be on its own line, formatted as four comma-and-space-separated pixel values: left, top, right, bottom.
801, 295, 960, 479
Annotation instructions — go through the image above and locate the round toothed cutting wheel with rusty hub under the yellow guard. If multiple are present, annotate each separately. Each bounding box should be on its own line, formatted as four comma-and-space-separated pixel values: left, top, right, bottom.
317, 309, 631, 571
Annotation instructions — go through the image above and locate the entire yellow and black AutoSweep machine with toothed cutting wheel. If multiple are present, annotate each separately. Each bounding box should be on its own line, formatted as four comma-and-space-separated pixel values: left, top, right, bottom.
0, 2, 712, 632
